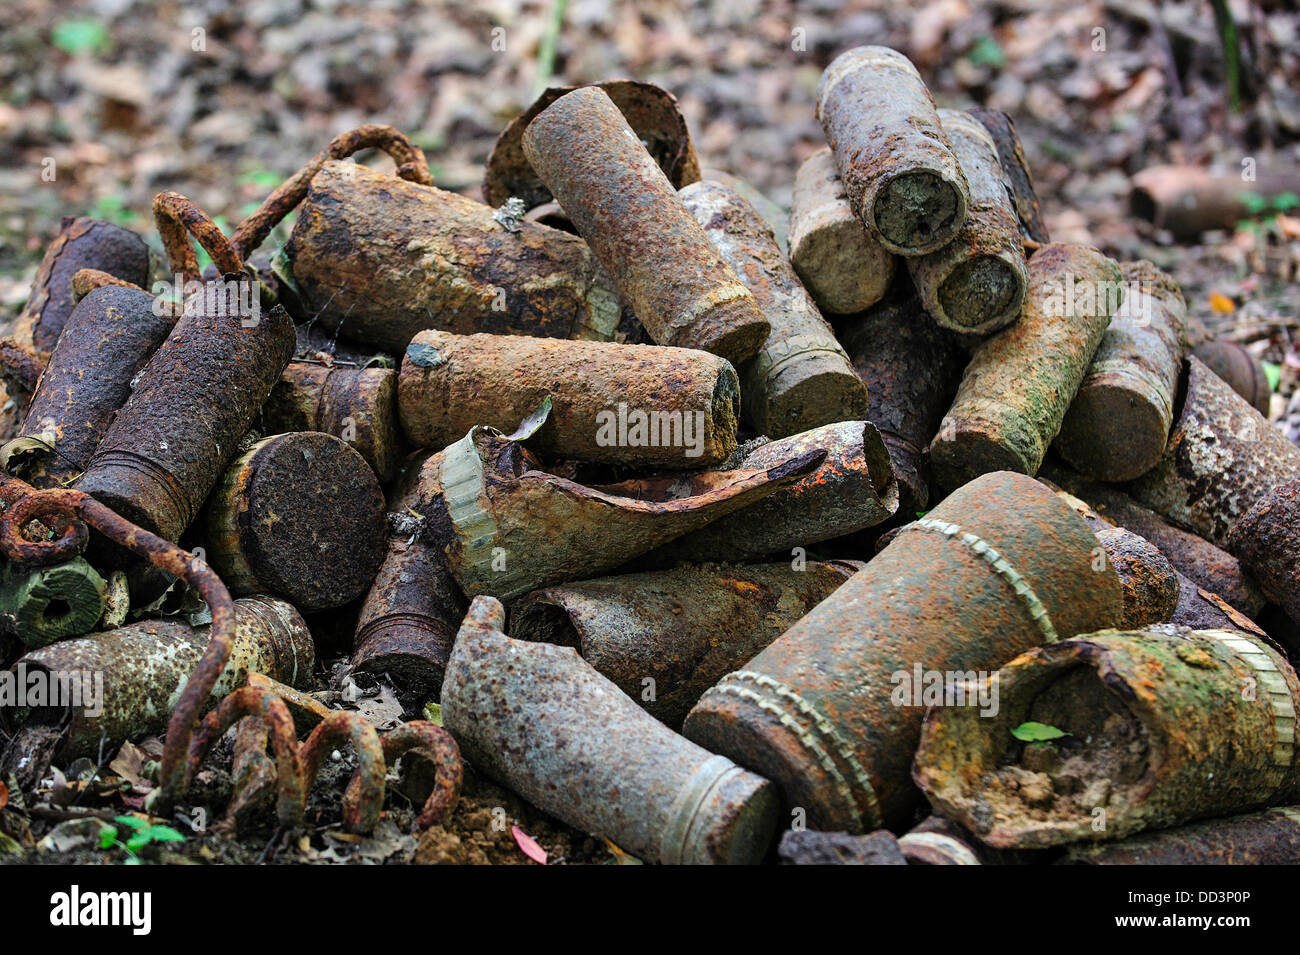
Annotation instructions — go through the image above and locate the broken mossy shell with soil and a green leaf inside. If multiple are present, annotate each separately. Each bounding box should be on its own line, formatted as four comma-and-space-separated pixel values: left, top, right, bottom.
914, 628, 1300, 848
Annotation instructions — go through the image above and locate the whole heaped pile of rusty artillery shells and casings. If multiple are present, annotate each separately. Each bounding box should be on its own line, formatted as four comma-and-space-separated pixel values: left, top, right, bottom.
0, 47, 1300, 865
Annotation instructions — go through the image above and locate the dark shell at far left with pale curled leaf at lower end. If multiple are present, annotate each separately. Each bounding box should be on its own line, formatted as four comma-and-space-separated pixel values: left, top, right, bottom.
10, 286, 173, 487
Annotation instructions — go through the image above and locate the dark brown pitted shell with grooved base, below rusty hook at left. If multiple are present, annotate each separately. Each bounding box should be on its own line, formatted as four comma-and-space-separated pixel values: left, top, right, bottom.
77, 291, 294, 541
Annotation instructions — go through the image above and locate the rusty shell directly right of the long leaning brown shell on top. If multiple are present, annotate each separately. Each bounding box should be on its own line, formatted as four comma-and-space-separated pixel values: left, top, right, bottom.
679, 181, 867, 438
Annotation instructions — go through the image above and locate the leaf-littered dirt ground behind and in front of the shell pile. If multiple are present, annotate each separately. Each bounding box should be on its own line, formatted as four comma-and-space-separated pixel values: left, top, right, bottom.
0, 0, 1300, 864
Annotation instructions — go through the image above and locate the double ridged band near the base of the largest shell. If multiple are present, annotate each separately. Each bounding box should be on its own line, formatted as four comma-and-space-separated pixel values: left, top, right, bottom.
706, 670, 884, 832
